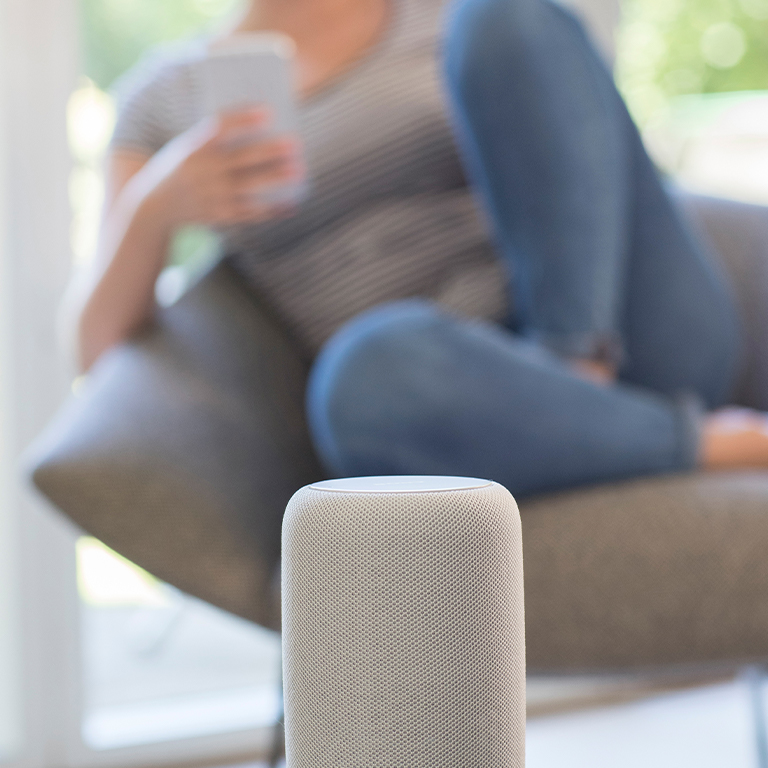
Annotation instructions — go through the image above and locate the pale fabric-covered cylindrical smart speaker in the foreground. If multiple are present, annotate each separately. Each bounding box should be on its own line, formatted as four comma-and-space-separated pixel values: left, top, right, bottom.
282, 476, 525, 768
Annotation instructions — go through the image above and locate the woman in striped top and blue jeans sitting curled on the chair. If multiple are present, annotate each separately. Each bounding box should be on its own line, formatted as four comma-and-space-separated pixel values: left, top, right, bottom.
72, 0, 768, 494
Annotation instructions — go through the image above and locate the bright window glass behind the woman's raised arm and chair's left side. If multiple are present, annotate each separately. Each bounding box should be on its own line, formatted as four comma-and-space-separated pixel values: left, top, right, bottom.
69, 0, 280, 749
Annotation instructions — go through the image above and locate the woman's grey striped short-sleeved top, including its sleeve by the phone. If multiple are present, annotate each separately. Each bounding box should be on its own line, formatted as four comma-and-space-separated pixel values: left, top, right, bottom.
113, 0, 509, 354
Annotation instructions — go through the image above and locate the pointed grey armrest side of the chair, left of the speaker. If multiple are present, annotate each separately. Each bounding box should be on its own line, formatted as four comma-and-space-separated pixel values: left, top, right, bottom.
29, 264, 323, 627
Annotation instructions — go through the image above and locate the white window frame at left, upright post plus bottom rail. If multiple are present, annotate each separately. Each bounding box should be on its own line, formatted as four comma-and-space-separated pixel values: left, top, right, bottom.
0, 0, 270, 768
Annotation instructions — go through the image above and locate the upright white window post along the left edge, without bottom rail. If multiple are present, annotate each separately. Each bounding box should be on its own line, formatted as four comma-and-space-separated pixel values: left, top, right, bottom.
0, 0, 81, 768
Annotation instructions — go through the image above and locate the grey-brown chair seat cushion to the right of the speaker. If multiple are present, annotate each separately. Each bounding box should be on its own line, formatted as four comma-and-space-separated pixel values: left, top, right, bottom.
520, 472, 768, 671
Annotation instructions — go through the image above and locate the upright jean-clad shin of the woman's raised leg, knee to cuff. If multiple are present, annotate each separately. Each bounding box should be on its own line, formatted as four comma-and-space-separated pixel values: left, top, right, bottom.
445, 0, 631, 357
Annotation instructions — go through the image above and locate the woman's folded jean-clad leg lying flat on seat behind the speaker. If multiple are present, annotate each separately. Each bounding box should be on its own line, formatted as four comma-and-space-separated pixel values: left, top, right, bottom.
307, 300, 697, 495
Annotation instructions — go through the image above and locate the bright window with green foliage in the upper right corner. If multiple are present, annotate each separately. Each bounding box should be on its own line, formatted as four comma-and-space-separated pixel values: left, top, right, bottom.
616, 0, 768, 204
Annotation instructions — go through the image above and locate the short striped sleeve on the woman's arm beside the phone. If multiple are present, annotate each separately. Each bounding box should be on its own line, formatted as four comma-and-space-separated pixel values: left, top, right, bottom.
110, 43, 204, 155
